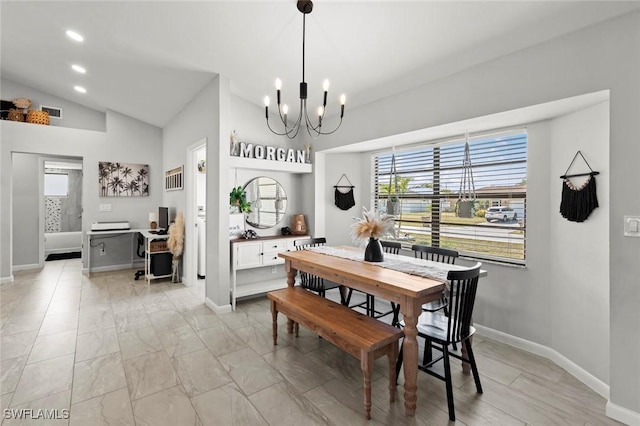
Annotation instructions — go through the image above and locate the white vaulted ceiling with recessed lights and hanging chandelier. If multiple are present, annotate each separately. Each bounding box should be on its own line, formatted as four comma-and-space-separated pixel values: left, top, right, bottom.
0, 0, 640, 127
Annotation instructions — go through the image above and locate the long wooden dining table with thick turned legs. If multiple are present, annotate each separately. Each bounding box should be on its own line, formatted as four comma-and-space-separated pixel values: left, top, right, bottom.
279, 247, 460, 416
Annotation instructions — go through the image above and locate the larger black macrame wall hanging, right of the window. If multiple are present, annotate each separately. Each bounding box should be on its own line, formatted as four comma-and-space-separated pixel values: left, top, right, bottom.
560, 151, 600, 222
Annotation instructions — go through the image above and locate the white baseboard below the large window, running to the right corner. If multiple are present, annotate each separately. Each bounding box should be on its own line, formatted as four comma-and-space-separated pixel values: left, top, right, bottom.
473, 324, 609, 400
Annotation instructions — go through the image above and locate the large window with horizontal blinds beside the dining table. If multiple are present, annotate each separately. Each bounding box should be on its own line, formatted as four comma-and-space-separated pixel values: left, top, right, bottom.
372, 130, 527, 264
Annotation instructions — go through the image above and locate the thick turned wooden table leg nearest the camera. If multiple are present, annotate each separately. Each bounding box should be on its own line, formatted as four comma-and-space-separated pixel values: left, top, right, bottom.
401, 300, 420, 416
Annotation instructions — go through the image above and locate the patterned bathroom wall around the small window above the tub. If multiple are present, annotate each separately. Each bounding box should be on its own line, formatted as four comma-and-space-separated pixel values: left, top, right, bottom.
45, 168, 82, 232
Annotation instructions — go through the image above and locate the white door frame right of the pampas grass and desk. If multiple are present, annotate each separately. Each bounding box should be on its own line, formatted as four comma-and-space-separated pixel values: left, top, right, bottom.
183, 138, 207, 286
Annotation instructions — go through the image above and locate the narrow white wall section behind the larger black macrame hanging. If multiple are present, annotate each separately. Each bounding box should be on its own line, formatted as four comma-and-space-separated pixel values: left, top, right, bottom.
549, 102, 610, 383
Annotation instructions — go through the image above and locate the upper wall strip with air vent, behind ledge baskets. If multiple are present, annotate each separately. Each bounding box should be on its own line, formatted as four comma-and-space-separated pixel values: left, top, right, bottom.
0, 78, 106, 132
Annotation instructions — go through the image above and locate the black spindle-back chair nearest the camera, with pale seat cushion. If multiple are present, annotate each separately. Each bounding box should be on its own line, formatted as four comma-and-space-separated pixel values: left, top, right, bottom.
396, 262, 482, 421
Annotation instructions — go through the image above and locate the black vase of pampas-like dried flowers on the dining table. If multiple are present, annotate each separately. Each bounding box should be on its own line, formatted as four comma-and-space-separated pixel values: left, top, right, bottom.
351, 209, 394, 262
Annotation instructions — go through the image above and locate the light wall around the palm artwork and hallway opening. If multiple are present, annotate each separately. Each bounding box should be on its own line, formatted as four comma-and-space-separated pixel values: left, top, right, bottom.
0, 111, 163, 274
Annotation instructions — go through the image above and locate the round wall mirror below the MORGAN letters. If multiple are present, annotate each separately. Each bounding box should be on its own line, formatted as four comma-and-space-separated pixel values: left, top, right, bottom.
244, 176, 287, 229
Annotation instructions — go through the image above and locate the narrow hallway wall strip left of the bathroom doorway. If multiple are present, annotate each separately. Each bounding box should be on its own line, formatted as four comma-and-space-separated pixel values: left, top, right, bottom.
12, 153, 40, 267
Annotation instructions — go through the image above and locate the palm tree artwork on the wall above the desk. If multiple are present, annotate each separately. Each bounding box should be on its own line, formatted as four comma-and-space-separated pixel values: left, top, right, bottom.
98, 161, 149, 197
